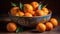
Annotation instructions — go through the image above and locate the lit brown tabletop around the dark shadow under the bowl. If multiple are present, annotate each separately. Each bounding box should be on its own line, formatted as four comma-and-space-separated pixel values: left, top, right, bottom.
0, 16, 60, 34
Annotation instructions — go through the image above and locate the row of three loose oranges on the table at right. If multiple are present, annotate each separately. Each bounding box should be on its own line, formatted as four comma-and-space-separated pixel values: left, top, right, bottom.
36, 18, 58, 32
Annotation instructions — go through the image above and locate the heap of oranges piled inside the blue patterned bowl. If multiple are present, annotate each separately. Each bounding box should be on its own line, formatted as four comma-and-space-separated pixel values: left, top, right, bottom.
10, 2, 49, 17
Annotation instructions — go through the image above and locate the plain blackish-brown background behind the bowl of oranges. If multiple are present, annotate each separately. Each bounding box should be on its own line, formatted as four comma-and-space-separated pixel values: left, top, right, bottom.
0, 0, 60, 15
